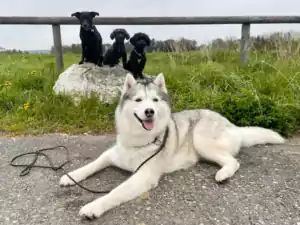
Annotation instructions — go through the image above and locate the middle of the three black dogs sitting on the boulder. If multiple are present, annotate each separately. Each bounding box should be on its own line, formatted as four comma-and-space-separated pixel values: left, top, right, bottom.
103, 29, 130, 67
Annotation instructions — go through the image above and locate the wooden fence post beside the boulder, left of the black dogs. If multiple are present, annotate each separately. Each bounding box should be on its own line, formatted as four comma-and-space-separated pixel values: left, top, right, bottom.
52, 24, 64, 72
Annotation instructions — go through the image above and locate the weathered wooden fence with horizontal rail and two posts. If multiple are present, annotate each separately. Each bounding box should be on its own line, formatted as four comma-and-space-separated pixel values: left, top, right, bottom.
0, 16, 300, 71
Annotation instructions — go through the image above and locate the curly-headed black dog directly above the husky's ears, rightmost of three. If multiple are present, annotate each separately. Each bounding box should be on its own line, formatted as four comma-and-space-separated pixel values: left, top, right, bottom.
124, 32, 151, 79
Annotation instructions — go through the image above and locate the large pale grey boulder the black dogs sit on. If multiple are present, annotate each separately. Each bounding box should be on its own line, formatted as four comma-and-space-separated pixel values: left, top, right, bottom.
53, 63, 141, 103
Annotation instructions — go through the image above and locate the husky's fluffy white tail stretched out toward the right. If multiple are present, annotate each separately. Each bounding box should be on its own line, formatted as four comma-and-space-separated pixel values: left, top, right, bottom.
238, 127, 285, 147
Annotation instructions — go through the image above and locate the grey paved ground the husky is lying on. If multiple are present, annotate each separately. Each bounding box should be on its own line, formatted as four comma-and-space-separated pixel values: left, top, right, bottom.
0, 135, 300, 225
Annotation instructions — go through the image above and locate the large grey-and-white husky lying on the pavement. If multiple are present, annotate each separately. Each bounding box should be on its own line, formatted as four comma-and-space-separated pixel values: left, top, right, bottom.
60, 73, 285, 219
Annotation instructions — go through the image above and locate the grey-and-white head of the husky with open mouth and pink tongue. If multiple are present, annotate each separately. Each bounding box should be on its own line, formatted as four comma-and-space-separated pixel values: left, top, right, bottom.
116, 73, 171, 136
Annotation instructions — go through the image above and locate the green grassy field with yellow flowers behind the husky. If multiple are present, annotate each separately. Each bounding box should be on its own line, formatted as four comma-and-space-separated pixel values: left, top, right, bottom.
0, 50, 300, 136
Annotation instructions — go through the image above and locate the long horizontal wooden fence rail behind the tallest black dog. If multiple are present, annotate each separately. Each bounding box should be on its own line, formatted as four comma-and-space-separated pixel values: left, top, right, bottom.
0, 15, 300, 25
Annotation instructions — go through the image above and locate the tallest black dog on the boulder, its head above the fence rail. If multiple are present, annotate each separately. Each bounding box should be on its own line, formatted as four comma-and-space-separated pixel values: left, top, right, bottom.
71, 12, 103, 67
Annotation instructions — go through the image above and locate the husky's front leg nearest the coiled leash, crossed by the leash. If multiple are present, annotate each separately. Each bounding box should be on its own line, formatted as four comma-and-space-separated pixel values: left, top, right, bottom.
59, 147, 116, 186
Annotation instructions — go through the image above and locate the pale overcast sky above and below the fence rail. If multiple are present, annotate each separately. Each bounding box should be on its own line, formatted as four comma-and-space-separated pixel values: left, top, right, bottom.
0, 0, 300, 50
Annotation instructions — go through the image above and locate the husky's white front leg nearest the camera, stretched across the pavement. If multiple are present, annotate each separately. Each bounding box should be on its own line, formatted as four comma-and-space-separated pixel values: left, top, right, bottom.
79, 162, 162, 219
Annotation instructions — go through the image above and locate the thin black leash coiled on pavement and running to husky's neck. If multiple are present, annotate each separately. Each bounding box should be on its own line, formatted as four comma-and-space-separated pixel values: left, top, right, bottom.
10, 127, 169, 194
